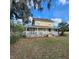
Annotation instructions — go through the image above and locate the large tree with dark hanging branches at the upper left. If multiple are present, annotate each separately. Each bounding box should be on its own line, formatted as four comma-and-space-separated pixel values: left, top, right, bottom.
10, 0, 51, 22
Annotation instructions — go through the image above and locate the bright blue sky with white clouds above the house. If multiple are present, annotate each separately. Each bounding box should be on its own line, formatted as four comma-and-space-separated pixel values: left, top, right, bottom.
31, 0, 69, 22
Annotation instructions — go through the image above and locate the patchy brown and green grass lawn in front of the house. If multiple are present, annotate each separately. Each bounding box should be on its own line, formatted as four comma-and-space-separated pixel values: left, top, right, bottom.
10, 35, 69, 59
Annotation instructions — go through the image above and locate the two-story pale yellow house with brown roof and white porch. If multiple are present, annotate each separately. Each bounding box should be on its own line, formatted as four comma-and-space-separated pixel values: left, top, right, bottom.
26, 18, 54, 37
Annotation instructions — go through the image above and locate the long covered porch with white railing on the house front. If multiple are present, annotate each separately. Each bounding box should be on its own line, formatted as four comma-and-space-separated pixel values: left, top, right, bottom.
26, 26, 53, 37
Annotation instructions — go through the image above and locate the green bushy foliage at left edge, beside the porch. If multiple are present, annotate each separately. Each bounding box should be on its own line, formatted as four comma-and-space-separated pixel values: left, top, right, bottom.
10, 22, 24, 44
